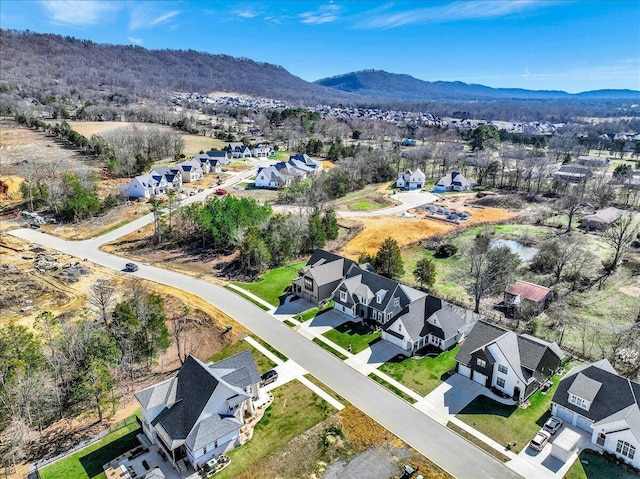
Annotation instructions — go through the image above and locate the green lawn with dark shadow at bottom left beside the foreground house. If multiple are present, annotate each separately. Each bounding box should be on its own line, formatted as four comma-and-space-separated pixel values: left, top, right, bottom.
40, 421, 142, 479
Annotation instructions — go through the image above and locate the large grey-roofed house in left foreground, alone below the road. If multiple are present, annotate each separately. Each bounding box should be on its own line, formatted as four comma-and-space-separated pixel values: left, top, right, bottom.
134, 350, 260, 470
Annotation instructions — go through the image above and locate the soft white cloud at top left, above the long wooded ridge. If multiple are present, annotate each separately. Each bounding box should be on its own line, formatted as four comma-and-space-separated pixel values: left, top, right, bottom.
40, 0, 120, 26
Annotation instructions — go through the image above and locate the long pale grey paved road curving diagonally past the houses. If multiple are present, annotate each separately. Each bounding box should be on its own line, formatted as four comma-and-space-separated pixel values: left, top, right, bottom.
9, 228, 521, 479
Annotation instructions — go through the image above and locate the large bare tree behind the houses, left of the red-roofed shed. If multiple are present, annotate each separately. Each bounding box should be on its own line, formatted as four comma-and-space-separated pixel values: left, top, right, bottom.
464, 233, 520, 313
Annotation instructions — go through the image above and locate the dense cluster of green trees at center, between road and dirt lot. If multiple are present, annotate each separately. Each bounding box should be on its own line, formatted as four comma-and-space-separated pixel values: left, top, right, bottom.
162, 195, 339, 276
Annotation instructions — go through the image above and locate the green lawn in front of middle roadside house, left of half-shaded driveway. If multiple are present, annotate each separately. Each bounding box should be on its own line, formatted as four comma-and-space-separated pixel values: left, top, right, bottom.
378, 346, 460, 396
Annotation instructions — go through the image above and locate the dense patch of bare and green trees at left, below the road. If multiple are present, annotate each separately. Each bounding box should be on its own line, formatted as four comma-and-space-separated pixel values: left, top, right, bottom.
0, 283, 170, 461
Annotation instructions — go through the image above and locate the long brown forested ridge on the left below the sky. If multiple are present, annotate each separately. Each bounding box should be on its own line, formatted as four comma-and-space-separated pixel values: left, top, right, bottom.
0, 30, 350, 103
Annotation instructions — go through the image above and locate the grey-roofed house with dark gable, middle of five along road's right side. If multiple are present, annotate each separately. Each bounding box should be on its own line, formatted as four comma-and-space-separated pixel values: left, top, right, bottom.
382, 295, 480, 355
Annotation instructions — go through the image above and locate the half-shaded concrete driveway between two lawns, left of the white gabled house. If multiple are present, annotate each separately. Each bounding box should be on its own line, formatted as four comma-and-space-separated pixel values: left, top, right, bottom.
414, 374, 487, 424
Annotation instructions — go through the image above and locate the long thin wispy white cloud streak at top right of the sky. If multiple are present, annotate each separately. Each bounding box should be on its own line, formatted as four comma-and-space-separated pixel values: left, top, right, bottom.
355, 0, 557, 29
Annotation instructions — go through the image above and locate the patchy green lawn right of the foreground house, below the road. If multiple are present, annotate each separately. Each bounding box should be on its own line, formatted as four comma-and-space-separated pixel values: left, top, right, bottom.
215, 381, 336, 479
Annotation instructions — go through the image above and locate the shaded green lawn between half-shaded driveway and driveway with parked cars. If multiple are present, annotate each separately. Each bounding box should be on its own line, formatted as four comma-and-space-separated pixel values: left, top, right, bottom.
457, 364, 573, 453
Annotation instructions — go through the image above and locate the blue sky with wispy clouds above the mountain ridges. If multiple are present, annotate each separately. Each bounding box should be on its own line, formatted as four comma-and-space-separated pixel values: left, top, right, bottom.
0, 0, 640, 93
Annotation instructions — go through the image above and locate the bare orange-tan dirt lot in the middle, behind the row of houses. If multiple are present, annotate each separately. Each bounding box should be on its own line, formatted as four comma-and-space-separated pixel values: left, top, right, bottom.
340, 194, 518, 259
